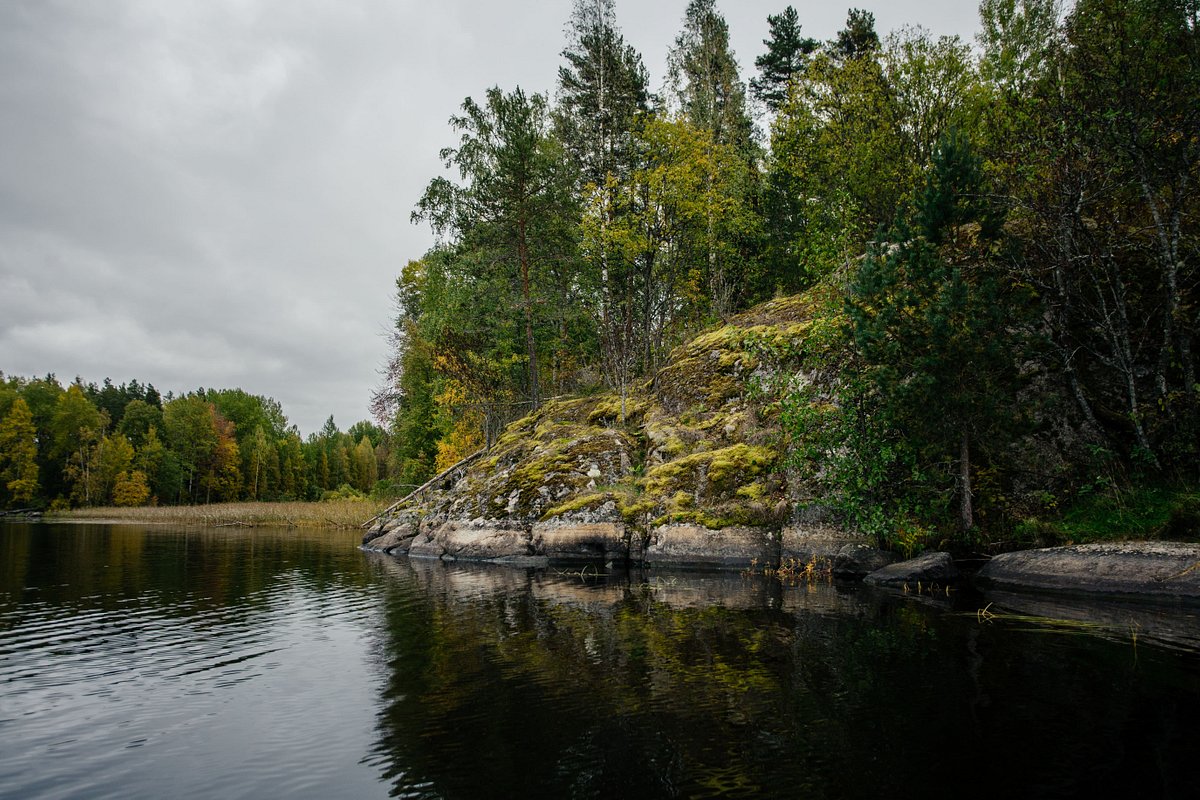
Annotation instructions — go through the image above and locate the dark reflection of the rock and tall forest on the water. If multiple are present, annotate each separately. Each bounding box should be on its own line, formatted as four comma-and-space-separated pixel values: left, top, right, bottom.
364, 559, 1200, 798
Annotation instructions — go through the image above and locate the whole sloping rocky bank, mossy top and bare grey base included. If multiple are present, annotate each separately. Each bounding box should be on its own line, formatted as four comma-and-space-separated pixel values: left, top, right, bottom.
364, 293, 890, 576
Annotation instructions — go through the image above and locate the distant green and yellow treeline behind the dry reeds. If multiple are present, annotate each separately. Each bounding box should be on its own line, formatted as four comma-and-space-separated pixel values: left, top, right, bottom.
0, 374, 388, 509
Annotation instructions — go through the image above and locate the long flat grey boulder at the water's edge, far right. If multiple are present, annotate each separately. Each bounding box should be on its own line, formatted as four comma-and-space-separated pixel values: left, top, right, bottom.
976, 542, 1200, 600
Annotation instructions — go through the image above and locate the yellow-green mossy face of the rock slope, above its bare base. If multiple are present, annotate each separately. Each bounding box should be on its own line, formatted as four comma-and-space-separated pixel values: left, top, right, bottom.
379, 287, 859, 561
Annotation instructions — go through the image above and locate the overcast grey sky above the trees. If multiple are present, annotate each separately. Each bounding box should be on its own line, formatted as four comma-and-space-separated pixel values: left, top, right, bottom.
0, 0, 977, 434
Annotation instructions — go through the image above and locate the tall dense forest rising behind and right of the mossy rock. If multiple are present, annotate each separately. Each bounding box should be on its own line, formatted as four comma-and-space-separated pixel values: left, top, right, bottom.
374, 0, 1200, 537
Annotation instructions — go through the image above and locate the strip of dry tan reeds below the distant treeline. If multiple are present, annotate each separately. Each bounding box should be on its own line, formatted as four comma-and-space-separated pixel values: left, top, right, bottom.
47, 500, 388, 529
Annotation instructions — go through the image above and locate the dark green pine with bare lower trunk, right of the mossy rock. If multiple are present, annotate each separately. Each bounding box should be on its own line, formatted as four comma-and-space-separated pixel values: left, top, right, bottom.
850, 132, 1014, 531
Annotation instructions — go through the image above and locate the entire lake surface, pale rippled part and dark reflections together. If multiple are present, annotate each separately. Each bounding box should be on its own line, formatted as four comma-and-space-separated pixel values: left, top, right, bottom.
0, 525, 1200, 798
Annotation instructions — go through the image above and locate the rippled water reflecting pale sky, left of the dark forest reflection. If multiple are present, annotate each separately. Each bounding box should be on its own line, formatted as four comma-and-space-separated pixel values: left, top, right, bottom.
0, 525, 385, 798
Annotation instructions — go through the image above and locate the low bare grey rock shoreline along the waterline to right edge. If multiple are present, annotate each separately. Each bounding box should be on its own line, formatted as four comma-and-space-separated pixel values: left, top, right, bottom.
361, 513, 1200, 604
